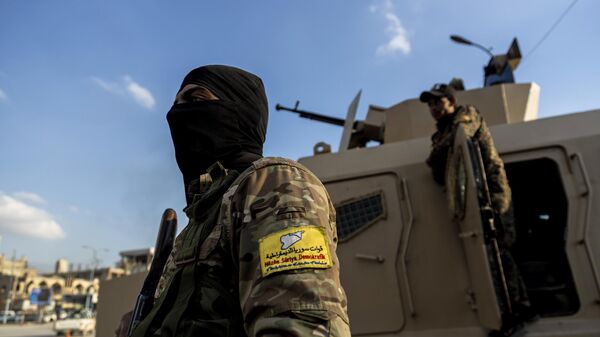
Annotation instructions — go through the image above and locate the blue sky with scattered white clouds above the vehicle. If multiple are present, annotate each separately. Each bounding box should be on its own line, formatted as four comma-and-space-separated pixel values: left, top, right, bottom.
0, 0, 600, 271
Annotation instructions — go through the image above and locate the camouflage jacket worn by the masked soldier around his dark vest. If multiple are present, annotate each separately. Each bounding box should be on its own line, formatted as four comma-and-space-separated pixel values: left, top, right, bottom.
156, 158, 350, 336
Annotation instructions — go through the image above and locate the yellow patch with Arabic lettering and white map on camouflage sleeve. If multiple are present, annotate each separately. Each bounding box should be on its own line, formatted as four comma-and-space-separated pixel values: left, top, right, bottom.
258, 226, 333, 276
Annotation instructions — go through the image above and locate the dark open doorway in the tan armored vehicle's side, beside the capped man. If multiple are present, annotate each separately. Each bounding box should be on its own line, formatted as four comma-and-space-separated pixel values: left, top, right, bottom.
506, 158, 579, 317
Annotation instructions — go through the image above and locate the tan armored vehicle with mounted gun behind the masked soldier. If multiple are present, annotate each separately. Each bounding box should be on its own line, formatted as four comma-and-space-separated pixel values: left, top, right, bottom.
97, 45, 600, 337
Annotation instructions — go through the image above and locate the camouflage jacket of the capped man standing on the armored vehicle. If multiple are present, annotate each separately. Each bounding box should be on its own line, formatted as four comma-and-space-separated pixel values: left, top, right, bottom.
427, 105, 511, 217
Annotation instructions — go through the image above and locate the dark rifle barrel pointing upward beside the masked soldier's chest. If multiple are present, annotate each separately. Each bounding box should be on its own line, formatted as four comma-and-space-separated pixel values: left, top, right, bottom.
127, 208, 177, 336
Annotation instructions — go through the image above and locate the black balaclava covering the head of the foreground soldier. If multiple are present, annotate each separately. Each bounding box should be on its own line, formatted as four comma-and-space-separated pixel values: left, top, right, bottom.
167, 65, 268, 190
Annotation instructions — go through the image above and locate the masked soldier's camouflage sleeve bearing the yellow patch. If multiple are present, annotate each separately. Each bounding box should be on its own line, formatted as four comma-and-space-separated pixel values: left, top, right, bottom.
225, 159, 350, 336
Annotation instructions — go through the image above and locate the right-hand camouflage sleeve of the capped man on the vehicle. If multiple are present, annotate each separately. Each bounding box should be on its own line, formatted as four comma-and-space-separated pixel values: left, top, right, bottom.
475, 110, 511, 216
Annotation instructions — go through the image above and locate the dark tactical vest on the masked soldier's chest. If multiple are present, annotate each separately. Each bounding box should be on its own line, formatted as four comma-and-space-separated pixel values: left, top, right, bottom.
132, 163, 246, 337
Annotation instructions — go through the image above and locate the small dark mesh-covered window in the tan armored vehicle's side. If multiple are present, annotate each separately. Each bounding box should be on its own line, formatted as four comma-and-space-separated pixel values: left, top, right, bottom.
335, 192, 385, 242
